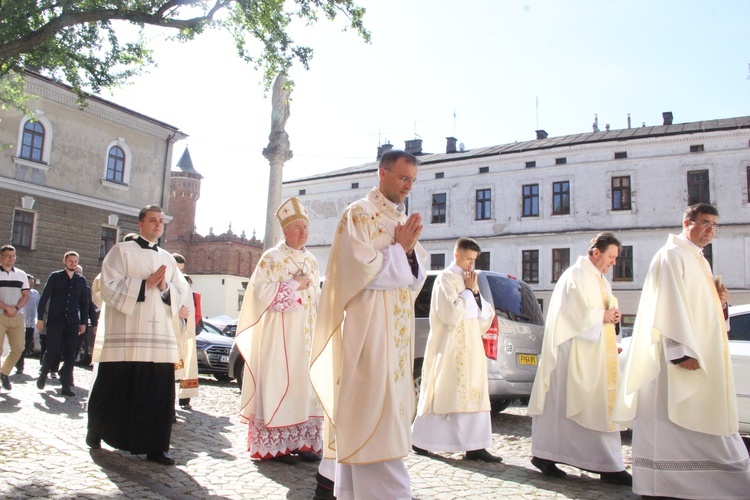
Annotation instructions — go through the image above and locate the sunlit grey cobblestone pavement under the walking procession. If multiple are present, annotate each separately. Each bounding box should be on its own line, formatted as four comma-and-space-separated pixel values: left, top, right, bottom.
0, 358, 637, 500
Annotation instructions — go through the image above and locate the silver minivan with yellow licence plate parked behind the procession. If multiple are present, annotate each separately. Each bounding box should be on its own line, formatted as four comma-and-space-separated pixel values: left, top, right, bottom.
414, 271, 544, 412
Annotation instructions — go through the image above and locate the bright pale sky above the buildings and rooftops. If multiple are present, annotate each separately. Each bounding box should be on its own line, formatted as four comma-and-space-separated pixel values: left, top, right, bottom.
102, 0, 750, 239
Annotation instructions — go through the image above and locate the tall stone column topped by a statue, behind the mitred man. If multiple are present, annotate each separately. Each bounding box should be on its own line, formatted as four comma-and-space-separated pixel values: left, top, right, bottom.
263, 73, 292, 251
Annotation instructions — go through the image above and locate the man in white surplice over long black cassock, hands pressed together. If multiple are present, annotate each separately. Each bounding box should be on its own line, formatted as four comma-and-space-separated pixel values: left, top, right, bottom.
86, 205, 189, 465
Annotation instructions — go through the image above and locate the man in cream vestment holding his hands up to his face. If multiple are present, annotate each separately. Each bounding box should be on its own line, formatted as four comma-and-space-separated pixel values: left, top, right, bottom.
412, 238, 503, 462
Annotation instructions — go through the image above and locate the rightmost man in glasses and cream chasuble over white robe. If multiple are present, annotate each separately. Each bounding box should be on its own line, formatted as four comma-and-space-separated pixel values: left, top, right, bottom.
615, 203, 750, 499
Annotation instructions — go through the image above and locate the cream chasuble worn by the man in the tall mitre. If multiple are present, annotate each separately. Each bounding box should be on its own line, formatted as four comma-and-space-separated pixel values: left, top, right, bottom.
235, 241, 323, 428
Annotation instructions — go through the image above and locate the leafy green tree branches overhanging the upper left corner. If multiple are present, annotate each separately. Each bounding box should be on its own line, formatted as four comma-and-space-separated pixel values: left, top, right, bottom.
0, 0, 370, 108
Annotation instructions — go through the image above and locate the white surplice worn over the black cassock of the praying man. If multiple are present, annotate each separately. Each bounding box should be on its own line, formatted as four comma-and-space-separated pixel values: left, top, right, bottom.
94, 241, 190, 363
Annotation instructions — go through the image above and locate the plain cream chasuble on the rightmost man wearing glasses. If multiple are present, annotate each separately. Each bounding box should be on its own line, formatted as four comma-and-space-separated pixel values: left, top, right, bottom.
615, 235, 738, 436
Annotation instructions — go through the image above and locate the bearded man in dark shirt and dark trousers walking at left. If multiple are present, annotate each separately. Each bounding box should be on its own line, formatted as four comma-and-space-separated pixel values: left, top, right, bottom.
36, 251, 89, 396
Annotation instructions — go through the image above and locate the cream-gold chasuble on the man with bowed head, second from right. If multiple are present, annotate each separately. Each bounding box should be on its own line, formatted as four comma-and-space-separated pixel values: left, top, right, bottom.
528, 256, 620, 432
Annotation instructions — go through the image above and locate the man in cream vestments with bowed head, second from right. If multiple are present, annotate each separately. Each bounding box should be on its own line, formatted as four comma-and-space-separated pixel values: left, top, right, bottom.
528, 232, 632, 485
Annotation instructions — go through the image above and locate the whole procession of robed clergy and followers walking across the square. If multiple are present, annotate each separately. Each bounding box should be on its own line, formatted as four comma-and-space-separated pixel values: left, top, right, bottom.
0, 150, 750, 499
